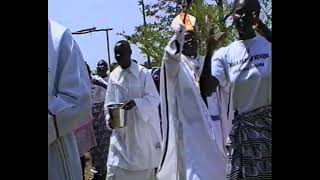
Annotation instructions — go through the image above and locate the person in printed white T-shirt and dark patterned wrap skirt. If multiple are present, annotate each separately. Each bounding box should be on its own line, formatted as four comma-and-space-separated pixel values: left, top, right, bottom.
200, 0, 272, 180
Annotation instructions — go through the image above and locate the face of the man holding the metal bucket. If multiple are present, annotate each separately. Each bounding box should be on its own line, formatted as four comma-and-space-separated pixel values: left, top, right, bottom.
114, 44, 132, 69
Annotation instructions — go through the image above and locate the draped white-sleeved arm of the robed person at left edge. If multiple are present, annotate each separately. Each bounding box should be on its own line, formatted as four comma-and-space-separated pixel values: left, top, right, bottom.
48, 31, 91, 136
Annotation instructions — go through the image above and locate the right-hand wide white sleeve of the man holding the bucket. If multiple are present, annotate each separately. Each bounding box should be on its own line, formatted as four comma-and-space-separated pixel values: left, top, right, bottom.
134, 72, 160, 121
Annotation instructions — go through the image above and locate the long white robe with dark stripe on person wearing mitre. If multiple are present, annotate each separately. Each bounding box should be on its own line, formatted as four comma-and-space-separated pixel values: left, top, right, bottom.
157, 25, 226, 180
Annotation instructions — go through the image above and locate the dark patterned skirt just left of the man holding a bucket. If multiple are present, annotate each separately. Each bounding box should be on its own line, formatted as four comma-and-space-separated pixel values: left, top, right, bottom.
90, 102, 112, 174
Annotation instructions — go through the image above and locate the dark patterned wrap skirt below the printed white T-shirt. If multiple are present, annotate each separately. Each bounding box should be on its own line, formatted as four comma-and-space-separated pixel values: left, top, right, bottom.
227, 106, 272, 180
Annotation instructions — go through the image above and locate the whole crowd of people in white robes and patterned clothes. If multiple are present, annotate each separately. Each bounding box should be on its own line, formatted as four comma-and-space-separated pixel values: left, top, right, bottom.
48, 0, 272, 180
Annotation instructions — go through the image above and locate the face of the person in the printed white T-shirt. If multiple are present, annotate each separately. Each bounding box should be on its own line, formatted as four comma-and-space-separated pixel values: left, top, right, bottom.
233, 0, 254, 36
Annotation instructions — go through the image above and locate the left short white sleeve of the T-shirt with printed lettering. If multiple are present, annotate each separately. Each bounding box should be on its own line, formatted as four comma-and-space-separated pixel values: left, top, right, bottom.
211, 48, 228, 87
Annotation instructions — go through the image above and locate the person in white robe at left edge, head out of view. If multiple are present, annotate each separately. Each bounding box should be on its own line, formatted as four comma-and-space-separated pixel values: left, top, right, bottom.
48, 20, 91, 180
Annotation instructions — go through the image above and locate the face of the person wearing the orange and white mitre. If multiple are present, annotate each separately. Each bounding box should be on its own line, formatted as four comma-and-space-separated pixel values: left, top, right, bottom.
182, 32, 198, 56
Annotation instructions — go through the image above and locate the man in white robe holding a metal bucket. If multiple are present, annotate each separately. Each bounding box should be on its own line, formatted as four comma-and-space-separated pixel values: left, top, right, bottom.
106, 41, 161, 180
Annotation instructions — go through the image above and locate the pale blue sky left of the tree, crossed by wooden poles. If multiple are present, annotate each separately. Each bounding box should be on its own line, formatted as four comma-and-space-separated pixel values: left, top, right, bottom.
48, 0, 156, 69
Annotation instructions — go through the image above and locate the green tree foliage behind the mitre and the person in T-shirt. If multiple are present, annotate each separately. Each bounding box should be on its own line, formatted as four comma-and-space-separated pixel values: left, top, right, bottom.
119, 0, 272, 66
